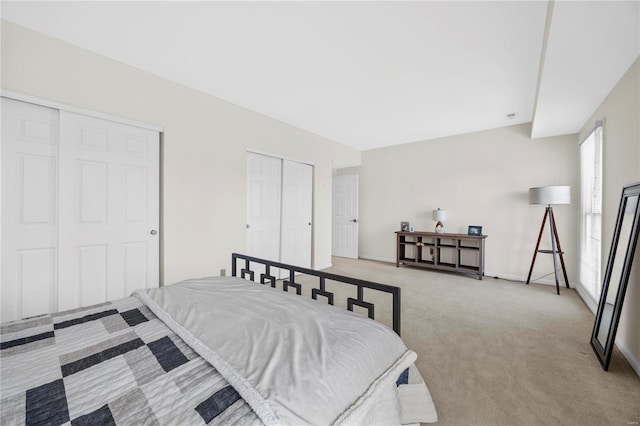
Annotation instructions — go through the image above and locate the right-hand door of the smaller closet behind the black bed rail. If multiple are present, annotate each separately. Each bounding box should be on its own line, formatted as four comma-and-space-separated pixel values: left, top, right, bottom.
281, 160, 313, 268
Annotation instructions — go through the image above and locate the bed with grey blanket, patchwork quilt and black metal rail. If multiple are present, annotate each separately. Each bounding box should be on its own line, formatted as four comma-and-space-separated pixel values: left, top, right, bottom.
0, 253, 437, 425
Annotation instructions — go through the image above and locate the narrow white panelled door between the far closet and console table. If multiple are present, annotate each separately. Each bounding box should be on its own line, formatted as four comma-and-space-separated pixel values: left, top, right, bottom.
331, 175, 358, 259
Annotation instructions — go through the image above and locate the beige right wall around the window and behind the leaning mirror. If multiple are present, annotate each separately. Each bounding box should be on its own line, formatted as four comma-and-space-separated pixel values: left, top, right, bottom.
580, 59, 640, 375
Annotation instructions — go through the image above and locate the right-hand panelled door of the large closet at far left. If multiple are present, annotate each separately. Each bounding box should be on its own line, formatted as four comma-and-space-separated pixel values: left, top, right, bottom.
59, 111, 160, 309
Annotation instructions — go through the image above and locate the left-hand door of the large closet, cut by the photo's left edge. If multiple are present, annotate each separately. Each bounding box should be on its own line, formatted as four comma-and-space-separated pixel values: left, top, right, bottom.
1, 98, 58, 322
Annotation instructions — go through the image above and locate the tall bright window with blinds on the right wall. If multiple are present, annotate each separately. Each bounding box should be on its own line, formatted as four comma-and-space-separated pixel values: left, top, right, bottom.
580, 121, 603, 300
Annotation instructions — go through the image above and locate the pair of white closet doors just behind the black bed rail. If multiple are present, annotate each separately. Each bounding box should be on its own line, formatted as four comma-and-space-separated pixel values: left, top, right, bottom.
247, 152, 313, 274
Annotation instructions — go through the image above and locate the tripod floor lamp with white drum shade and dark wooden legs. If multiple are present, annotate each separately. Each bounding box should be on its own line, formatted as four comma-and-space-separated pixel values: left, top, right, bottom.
527, 186, 571, 294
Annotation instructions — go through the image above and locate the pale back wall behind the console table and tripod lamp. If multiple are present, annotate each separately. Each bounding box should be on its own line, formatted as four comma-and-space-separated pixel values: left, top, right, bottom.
360, 124, 579, 283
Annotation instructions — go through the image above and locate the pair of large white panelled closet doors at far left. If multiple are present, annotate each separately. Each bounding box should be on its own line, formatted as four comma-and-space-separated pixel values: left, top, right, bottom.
1, 98, 159, 321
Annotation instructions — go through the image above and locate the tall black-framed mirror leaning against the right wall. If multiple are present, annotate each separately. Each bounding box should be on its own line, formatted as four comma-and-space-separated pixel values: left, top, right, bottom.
591, 183, 640, 371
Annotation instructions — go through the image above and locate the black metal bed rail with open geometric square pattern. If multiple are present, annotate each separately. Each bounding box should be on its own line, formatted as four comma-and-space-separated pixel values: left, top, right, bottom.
231, 253, 400, 336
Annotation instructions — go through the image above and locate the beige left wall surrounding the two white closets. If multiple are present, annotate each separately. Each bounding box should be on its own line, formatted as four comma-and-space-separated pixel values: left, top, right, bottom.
2, 21, 360, 283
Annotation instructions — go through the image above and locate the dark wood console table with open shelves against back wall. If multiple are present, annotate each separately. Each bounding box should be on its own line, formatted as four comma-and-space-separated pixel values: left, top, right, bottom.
396, 231, 487, 280
